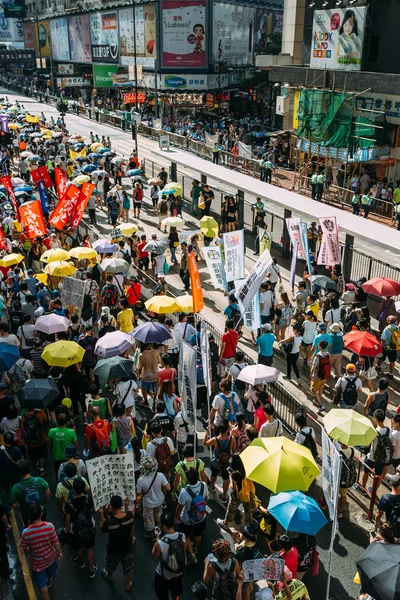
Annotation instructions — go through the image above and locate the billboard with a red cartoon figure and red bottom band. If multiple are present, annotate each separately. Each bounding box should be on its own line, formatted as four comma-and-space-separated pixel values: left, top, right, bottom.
161, 0, 208, 69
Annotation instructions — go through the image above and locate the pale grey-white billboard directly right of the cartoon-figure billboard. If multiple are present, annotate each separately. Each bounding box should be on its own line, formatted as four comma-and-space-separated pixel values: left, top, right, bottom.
213, 2, 255, 68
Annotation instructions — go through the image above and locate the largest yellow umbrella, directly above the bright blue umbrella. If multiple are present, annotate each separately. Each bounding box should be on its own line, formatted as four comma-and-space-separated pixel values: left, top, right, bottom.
240, 437, 319, 494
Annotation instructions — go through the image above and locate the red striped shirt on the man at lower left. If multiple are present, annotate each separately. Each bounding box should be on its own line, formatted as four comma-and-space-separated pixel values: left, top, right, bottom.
21, 521, 58, 571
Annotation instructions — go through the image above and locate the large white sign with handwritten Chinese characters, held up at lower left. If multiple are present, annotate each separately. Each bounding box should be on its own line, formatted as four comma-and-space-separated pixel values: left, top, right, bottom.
86, 453, 136, 510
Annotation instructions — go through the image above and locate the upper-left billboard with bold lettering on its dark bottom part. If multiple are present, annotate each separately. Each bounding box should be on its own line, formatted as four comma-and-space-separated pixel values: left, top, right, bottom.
90, 10, 119, 63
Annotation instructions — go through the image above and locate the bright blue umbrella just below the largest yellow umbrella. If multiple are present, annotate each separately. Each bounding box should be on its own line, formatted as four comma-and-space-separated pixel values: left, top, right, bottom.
268, 491, 328, 535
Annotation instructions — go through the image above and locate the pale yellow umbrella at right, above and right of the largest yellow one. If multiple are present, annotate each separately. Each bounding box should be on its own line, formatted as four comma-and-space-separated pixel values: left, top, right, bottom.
323, 408, 377, 446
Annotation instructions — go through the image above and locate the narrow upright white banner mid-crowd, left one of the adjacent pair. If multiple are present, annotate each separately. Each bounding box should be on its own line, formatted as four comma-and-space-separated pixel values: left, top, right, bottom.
178, 341, 197, 427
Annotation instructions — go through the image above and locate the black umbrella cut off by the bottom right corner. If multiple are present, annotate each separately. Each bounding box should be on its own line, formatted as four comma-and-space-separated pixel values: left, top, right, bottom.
357, 542, 400, 600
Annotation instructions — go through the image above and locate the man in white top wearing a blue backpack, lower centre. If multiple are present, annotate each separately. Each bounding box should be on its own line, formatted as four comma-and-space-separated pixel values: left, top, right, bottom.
175, 467, 208, 563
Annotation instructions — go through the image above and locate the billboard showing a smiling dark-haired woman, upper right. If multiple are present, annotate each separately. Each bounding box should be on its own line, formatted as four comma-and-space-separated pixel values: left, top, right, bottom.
310, 6, 367, 71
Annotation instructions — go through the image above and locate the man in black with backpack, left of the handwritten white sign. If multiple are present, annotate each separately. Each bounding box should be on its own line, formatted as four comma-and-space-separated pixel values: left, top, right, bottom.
65, 476, 97, 579
